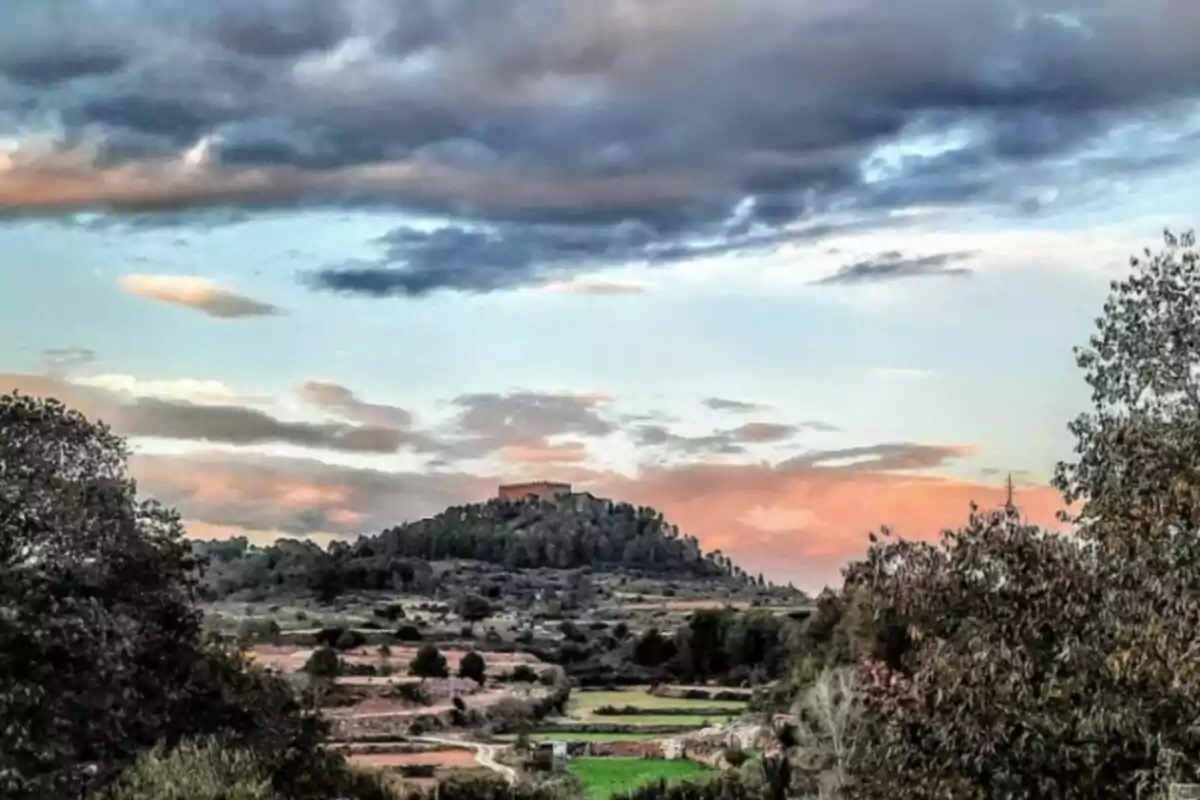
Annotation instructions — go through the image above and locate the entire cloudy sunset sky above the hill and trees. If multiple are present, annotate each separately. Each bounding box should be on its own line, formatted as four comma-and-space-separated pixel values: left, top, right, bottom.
0, 0, 1200, 590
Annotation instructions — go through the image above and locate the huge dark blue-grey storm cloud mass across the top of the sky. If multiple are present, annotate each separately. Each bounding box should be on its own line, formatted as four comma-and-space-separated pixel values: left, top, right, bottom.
0, 0, 1200, 296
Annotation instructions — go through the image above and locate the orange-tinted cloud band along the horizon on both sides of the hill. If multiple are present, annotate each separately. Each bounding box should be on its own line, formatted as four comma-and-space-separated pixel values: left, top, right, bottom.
117, 445, 1061, 591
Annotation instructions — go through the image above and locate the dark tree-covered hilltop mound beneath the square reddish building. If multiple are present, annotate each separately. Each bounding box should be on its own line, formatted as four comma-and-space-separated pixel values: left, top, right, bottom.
370, 494, 745, 578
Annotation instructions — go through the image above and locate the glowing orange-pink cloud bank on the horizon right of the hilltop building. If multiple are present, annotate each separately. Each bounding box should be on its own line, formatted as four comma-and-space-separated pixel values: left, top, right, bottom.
580, 465, 1062, 590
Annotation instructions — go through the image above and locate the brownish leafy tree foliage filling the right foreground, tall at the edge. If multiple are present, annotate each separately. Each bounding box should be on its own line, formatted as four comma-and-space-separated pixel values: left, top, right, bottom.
845, 235, 1200, 800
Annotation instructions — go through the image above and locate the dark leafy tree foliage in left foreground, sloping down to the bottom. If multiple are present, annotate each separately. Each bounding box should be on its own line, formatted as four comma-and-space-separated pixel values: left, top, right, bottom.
0, 395, 379, 800
